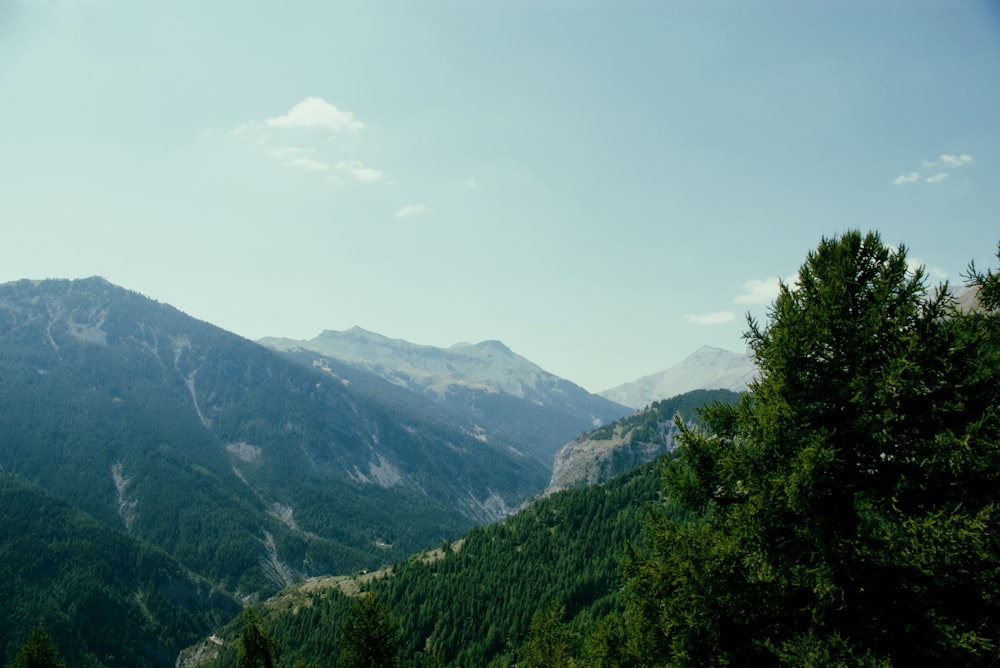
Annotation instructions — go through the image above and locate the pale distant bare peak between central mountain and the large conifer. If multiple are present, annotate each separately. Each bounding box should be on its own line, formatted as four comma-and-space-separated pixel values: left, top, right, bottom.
599, 346, 757, 409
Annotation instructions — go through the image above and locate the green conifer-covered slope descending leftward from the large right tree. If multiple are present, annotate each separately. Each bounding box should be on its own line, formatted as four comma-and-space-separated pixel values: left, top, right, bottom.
181, 461, 661, 668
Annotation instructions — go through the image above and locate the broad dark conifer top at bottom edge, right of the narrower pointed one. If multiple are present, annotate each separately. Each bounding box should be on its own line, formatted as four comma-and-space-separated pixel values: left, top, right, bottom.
337, 592, 400, 668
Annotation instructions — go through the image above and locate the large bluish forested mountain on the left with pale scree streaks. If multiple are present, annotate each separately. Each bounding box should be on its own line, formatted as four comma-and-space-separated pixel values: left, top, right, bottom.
0, 278, 548, 600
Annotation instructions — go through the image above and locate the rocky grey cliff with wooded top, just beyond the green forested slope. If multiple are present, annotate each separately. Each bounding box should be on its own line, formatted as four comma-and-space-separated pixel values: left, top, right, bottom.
545, 390, 739, 494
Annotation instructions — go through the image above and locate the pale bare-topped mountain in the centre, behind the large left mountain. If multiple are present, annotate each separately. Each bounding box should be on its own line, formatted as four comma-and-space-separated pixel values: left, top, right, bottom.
260, 327, 631, 465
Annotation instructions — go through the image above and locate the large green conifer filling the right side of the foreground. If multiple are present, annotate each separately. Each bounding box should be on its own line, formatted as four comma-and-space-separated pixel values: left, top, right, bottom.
626, 232, 1000, 666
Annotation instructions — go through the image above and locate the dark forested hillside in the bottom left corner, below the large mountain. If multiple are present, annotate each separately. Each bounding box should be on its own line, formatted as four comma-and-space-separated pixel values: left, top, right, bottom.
0, 473, 240, 668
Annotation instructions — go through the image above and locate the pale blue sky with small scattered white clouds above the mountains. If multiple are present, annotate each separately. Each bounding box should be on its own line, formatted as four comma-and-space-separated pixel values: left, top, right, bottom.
0, 0, 1000, 392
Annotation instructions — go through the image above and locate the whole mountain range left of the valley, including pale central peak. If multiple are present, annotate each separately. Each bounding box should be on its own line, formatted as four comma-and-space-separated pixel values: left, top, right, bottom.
0, 278, 752, 666
